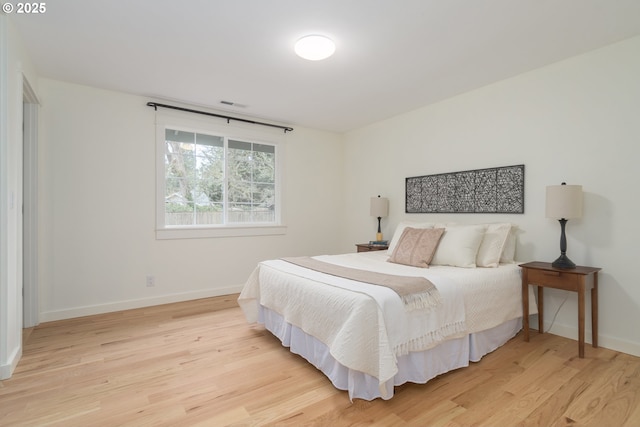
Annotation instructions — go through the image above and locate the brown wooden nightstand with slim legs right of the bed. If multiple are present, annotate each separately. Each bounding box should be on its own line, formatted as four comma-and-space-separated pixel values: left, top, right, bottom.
520, 262, 601, 358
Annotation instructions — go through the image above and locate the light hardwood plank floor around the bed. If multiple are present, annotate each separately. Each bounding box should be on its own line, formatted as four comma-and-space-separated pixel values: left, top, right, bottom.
0, 295, 640, 427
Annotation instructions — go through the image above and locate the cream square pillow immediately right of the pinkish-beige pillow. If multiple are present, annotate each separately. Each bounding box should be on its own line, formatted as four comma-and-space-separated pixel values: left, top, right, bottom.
431, 224, 487, 268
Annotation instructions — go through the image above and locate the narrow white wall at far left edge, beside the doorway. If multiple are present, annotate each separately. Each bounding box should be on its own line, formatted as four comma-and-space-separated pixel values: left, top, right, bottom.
0, 13, 37, 379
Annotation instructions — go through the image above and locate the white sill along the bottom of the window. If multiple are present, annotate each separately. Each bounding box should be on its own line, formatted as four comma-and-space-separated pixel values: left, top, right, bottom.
156, 225, 287, 240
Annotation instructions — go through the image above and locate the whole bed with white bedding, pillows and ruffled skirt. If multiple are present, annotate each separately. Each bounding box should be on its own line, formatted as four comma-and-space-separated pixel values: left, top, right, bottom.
238, 222, 536, 400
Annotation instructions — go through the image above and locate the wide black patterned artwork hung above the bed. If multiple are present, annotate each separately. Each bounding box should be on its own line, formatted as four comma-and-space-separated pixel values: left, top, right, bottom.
405, 165, 524, 213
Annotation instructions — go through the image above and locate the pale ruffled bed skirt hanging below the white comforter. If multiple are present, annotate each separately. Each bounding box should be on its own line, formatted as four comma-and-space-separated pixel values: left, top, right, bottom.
259, 306, 522, 400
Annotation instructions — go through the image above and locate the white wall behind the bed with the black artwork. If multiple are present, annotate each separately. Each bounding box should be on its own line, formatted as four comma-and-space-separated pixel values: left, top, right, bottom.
342, 38, 640, 355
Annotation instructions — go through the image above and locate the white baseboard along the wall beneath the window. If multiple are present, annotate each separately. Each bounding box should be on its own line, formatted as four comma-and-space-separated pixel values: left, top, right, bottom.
40, 285, 244, 322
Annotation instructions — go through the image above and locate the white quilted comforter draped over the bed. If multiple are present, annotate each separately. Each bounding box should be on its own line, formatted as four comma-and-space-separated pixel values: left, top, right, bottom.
238, 252, 522, 394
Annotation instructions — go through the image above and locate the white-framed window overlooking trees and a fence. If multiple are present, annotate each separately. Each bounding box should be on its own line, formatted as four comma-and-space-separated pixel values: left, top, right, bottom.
157, 115, 284, 238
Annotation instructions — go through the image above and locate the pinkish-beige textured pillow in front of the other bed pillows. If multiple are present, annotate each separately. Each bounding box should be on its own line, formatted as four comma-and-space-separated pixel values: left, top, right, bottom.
389, 227, 444, 268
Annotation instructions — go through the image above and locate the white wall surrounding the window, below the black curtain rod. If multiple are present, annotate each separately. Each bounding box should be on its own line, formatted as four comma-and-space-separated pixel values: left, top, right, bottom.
39, 79, 343, 321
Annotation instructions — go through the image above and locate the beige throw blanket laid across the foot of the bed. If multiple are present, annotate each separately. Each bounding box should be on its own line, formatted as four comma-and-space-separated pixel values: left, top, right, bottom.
282, 257, 440, 310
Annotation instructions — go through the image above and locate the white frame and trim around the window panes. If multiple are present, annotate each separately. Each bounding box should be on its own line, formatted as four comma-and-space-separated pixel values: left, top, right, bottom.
156, 112, 287, 240
